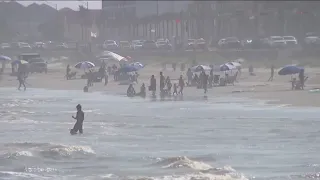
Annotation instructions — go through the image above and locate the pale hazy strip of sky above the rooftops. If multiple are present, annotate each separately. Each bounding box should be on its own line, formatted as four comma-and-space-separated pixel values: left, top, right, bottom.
17, 0, 101, 10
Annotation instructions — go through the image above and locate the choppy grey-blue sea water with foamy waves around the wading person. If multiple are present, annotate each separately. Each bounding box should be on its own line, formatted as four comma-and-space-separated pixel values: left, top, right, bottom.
0, 88, 320, 180
